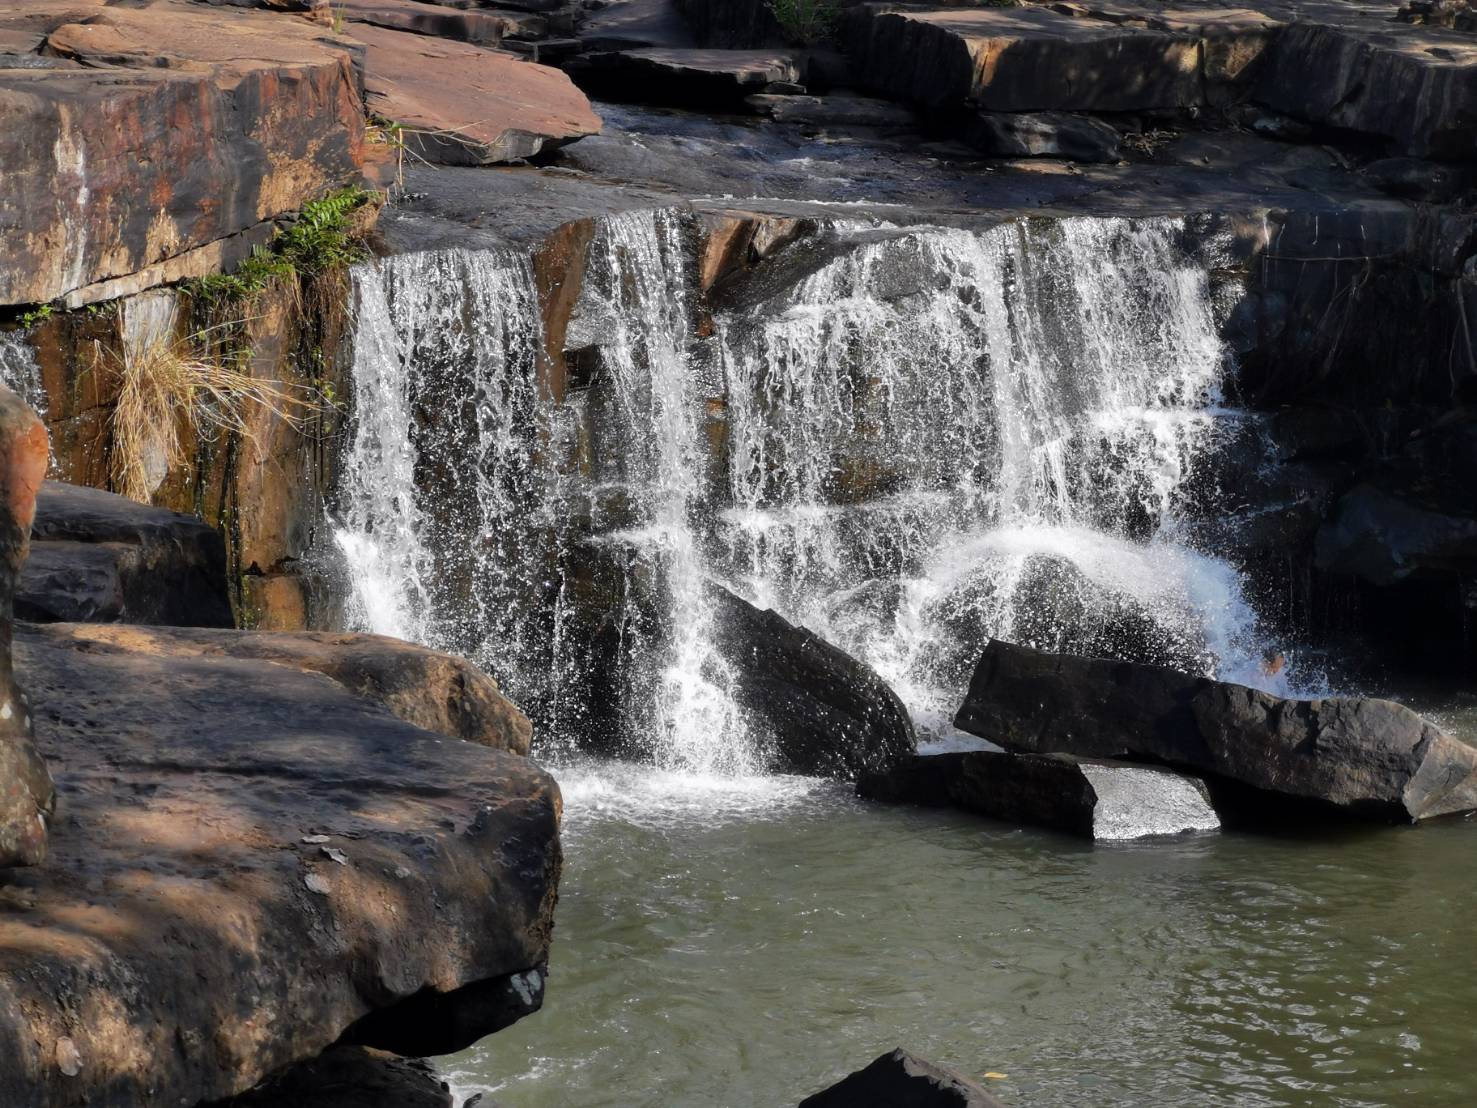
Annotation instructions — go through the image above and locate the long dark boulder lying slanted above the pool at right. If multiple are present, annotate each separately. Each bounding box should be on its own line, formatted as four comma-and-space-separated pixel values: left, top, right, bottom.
954, 640, 1477, 821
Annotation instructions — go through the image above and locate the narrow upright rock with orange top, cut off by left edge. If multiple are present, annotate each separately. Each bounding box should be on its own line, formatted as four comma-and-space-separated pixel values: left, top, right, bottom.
0, 386, 56, 867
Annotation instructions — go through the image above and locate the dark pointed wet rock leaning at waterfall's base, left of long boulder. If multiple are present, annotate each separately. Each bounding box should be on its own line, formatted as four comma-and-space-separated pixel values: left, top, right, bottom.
710, 587, 916, 780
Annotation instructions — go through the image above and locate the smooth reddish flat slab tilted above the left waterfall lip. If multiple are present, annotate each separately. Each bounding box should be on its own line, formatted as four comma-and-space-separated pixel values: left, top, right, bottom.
353, 25, 600, 165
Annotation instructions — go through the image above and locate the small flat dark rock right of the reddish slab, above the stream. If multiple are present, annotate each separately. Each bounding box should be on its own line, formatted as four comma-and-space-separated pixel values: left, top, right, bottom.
579, 47, 803, 106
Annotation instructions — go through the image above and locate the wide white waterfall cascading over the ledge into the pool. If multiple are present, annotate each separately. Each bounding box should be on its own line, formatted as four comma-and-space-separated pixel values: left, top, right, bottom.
335, 211, 1258, 773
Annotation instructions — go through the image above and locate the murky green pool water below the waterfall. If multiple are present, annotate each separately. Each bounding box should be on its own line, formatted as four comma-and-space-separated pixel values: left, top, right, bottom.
446, 723, 1477, 1108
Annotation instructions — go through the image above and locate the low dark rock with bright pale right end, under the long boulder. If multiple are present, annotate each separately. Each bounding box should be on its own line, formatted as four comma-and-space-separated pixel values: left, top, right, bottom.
857, 750, 1220, 841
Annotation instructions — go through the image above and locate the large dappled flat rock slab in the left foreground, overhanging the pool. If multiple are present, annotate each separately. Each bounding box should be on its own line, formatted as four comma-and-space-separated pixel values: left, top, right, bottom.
0, 626, 560, 1108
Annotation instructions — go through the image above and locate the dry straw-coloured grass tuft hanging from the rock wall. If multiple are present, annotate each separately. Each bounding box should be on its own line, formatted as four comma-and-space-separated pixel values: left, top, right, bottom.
103, 327, 319, 504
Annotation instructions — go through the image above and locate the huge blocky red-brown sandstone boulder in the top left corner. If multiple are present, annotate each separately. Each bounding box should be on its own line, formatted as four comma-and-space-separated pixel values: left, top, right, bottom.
0, 0, 363, 306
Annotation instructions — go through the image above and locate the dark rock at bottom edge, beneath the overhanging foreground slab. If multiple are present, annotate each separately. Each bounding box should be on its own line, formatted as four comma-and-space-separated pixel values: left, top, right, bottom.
216, 1046, 455, 1108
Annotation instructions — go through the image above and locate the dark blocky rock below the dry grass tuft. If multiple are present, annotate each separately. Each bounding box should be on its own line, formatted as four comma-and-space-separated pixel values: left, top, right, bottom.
16, 482, 233, 626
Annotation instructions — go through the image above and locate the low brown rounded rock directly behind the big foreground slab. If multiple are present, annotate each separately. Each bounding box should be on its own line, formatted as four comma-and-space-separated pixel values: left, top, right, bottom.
54, 626, 533, 755
